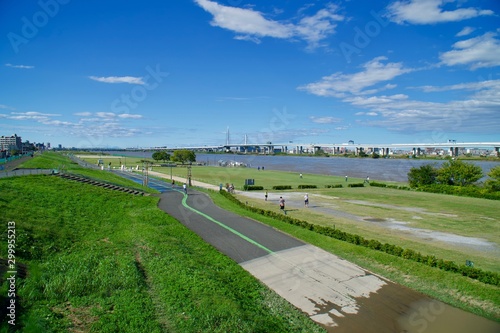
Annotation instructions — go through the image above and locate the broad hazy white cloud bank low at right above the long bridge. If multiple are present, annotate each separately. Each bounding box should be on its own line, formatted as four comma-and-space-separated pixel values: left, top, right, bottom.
350, 80, 500, 133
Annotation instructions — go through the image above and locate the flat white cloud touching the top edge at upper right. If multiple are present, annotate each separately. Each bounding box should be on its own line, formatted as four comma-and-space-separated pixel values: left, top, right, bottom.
387, 0, 494, 24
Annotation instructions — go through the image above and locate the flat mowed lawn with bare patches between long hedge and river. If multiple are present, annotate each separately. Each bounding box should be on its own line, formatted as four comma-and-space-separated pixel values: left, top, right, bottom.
146, 166, 500, 272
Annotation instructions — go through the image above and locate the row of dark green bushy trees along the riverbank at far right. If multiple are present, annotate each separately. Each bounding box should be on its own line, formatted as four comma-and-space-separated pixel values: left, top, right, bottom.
408, 160, 500, 191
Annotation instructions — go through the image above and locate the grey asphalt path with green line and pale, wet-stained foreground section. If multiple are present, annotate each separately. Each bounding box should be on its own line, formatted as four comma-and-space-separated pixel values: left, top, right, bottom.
103, 172, 500, 333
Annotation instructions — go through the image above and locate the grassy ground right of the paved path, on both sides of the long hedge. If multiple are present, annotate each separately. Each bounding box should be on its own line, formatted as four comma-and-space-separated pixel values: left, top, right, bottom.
29, 154, 500, 321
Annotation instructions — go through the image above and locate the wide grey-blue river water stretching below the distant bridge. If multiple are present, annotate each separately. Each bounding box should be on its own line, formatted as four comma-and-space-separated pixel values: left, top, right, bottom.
107, 151, 500, 182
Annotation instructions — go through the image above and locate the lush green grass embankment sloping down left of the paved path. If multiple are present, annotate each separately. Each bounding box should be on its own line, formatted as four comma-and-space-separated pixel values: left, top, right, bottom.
0, 154, 323, 333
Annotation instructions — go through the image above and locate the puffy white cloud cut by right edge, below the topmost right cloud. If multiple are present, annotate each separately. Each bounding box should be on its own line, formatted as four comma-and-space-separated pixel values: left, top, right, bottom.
439, 32, 500, 69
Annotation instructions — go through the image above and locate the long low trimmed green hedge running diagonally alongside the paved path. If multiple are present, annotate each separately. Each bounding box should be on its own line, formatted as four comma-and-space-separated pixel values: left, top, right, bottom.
219, 189, 500, 286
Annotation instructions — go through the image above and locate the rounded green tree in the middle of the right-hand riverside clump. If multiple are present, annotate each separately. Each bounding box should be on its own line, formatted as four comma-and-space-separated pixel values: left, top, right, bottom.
437, 160, 483, 186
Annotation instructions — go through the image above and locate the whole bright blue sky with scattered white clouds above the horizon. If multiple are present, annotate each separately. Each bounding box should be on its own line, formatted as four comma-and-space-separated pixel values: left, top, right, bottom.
0, 0, 500, 148
